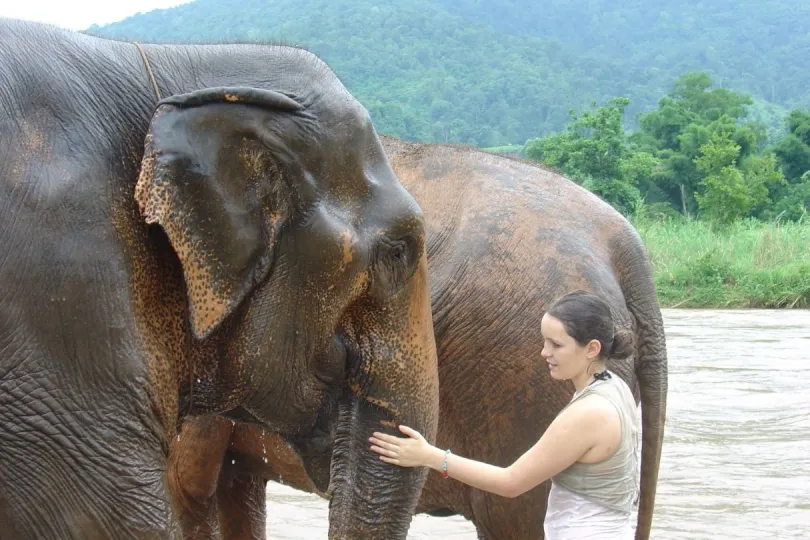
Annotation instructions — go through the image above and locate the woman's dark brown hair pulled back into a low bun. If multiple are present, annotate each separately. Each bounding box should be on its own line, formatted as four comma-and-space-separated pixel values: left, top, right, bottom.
547, 291, 635, 360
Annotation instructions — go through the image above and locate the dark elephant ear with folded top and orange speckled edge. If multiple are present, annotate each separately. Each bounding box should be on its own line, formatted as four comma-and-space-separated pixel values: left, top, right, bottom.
135, 88, 306, 339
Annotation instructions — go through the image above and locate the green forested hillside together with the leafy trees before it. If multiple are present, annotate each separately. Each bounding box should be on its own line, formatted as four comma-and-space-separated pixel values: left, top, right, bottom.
88, 0, 810, 223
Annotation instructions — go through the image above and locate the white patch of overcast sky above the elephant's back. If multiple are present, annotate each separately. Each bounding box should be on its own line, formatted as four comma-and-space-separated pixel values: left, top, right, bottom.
0, 0, 190, 30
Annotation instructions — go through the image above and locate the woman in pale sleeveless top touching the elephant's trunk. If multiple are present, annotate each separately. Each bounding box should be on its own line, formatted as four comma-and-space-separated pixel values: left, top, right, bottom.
369, 291, 638, 540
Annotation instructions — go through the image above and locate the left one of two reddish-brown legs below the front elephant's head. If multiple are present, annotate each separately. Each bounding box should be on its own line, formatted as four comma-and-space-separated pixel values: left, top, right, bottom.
167, 417, 234, 540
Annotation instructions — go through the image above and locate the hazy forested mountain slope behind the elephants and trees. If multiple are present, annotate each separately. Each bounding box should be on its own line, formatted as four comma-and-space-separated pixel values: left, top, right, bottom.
87, 0, 810, 146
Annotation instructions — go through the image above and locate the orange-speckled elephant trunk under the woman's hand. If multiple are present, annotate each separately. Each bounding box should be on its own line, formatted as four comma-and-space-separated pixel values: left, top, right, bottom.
329, 255, 439, 540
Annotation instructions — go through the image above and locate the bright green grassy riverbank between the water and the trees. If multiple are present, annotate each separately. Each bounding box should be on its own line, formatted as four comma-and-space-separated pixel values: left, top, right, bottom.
633, 215, 810, 309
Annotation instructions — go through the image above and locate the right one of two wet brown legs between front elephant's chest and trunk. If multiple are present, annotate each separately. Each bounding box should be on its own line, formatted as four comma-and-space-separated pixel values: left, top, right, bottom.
217, 474, 267, 540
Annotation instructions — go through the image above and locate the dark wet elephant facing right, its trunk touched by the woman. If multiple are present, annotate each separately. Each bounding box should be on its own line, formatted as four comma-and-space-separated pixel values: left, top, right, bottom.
0, 19, 439, 540
